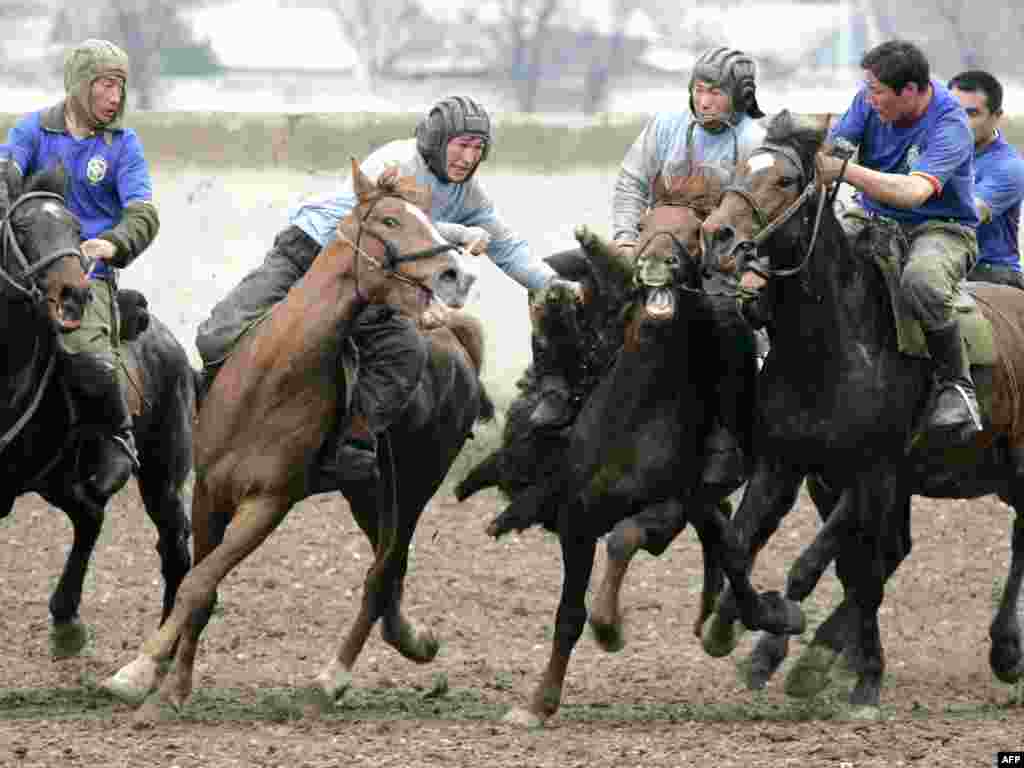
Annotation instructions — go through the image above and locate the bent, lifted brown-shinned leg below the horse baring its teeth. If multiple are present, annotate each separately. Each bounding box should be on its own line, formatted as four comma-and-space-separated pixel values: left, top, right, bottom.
590, 500, 686, 652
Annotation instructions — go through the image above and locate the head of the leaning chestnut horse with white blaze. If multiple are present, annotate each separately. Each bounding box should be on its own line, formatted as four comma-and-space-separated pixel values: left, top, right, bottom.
338, 158, 477, 316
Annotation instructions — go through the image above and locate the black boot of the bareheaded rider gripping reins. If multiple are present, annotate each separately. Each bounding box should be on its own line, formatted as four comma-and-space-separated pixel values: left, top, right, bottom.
925, 322, 983, 445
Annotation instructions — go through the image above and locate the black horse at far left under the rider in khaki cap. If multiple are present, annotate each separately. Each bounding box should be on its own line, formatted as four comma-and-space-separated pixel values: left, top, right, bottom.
0, 164, 196, 657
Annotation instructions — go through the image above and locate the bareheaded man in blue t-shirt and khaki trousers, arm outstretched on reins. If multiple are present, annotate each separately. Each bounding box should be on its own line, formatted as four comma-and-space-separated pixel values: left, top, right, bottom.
816, 40, 982, 442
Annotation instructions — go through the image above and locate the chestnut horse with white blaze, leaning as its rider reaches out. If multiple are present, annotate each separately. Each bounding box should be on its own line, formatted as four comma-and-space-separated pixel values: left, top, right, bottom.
102, 159, 493, 721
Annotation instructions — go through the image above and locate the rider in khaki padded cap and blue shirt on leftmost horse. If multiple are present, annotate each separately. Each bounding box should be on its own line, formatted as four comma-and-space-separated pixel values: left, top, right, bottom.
0, 39, 160, 500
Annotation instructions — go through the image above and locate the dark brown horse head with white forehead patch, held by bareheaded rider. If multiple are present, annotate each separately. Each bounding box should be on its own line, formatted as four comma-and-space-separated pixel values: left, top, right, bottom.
701, 111, 828, 276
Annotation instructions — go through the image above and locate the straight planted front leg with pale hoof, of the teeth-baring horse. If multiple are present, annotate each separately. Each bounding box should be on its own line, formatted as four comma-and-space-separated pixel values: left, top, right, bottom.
504, 506, 597, 728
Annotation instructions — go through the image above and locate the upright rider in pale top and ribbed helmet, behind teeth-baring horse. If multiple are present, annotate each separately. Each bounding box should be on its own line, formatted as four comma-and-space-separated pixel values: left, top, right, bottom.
531, 46, 765, 484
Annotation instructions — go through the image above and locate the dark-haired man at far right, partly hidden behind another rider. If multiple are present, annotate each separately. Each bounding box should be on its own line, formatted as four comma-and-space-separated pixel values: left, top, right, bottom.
946, 70, 1024, 289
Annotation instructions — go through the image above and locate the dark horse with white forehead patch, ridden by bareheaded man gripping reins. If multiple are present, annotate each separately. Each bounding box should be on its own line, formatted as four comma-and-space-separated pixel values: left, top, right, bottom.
702, 112, 1024, 718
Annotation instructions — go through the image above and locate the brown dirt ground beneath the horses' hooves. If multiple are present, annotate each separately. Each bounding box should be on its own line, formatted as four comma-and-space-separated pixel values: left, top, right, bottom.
0, 475, 1024, 768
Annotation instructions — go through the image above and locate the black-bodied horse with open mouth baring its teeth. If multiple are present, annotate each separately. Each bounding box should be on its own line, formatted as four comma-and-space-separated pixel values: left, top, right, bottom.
461, 176, 802, 727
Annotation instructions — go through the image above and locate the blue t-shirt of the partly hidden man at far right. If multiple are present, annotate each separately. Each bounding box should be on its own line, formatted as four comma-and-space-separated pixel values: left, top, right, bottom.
974, 134, 1024, 271
